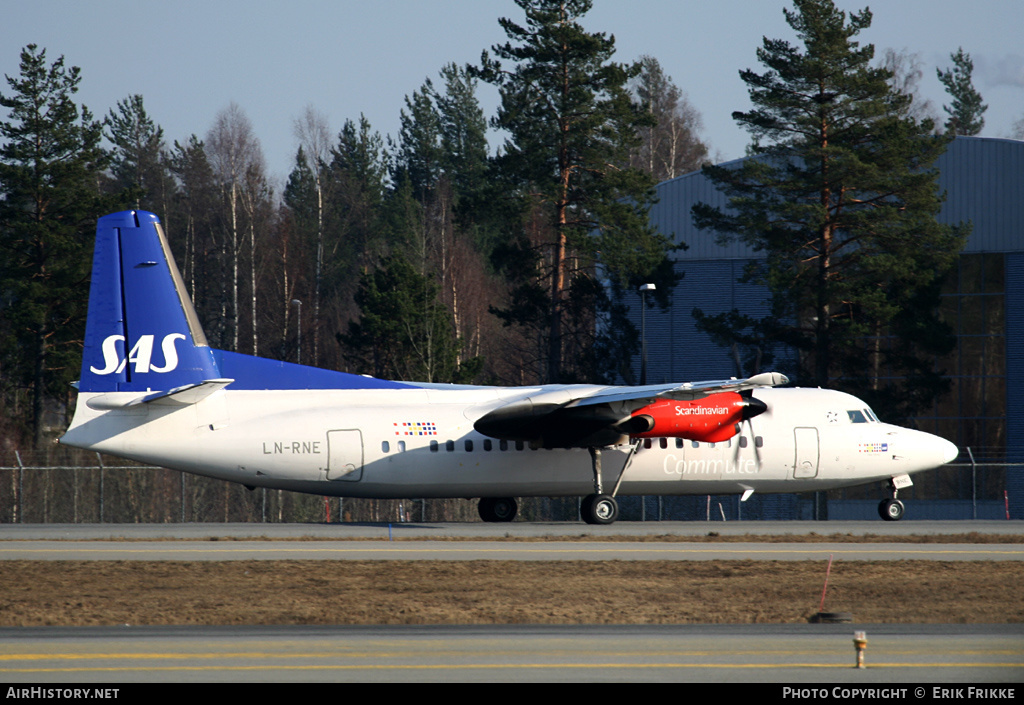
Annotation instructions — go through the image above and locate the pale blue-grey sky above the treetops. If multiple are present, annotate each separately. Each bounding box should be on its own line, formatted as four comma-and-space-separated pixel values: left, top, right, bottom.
0, 0, 1024, 193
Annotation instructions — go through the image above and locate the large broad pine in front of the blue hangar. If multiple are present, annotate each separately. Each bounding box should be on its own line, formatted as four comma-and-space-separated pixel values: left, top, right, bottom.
693, 0, 966, 414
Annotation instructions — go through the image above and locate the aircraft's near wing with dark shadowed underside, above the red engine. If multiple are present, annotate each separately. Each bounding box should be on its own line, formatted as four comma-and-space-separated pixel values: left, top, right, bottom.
473, 372, 790, 448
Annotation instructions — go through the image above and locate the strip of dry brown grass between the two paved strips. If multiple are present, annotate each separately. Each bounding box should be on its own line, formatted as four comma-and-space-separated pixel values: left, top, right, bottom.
0, 561, 1024, 626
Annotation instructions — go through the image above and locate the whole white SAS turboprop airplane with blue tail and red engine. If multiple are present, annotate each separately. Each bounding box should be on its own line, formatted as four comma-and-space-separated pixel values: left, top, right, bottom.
60, 211, 956, 524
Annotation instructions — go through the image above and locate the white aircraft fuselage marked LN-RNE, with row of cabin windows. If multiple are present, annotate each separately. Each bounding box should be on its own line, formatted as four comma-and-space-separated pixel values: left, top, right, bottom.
61, 387, 955, 498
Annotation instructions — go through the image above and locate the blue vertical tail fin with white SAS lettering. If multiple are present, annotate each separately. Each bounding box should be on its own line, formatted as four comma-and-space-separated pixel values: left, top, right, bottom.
79, 211, 220, 391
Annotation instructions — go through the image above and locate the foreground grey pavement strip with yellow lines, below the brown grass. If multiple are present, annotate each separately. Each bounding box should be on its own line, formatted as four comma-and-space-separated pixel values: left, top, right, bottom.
0, 624, 1024, 684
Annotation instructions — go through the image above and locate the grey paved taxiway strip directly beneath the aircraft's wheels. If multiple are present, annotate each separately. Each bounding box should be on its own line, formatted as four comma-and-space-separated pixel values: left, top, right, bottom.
0, 522, 1024, 561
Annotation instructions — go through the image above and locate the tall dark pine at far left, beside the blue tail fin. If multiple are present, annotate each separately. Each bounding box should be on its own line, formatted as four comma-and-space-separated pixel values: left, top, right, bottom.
0, 44, 123, 447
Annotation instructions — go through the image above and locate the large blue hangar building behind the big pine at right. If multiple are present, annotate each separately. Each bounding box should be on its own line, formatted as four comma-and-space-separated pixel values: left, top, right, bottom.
628, 137, 1024, 520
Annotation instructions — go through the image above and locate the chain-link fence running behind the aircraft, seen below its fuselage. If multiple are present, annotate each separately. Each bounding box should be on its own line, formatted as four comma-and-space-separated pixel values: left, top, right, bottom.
0, 447, 1007, 524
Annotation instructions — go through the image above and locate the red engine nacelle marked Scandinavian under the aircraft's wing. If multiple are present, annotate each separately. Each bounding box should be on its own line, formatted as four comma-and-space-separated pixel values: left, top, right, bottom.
630, 391, 767, 443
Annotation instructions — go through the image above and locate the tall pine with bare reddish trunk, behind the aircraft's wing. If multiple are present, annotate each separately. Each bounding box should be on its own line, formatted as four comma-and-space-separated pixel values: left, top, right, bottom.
471, 0, 669, 382
